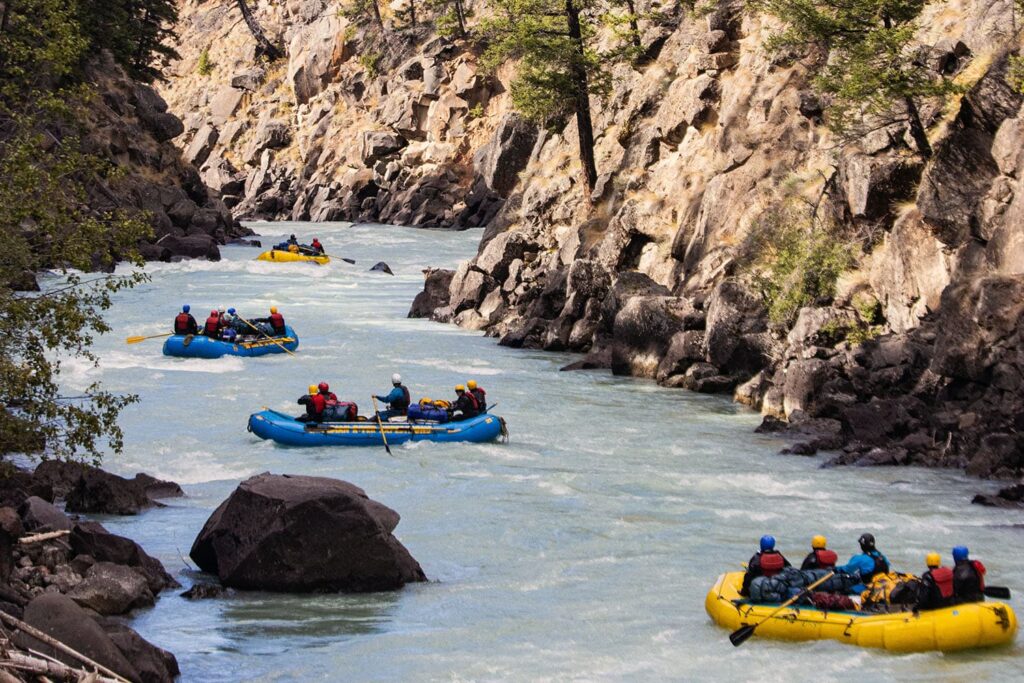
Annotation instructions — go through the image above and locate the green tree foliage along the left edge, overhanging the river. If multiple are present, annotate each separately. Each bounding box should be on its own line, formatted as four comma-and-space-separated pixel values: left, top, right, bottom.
0, 0, 166, 461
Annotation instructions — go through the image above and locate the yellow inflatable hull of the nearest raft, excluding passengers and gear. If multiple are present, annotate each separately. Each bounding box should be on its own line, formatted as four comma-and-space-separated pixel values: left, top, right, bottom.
705, 571, 1017, 652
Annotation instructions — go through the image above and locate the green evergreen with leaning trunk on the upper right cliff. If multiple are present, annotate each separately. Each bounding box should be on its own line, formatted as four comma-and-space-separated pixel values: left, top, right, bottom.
755, 0, 954, 158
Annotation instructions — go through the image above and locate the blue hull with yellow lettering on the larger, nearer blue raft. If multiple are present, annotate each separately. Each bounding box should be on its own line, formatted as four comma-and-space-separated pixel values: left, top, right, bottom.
249, 410, 504, 445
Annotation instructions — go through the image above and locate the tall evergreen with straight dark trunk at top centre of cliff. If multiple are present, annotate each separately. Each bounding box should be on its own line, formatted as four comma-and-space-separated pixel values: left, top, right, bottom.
479, 0, 609, 197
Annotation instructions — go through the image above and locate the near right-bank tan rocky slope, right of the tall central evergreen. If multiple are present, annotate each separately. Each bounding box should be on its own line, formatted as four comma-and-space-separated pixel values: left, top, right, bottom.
411, 0, 1024, 489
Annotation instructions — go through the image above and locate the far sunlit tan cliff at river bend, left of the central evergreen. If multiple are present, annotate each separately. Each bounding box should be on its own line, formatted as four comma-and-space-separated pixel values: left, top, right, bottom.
162, 0, 525, 226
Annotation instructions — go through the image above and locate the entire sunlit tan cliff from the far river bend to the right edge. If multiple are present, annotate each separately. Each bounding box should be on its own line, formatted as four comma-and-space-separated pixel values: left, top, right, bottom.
163, 0, 1024, 477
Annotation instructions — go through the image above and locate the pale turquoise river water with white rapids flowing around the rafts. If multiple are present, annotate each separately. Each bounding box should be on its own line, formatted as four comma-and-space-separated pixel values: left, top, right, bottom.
59, 223, 1024, 681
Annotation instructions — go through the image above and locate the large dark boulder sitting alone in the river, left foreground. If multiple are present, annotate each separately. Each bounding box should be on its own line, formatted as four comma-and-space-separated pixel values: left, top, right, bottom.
189, 472, 426, 593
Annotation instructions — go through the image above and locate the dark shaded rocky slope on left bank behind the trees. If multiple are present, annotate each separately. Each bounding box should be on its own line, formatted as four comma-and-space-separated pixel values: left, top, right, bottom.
83, 53, 243, 260
